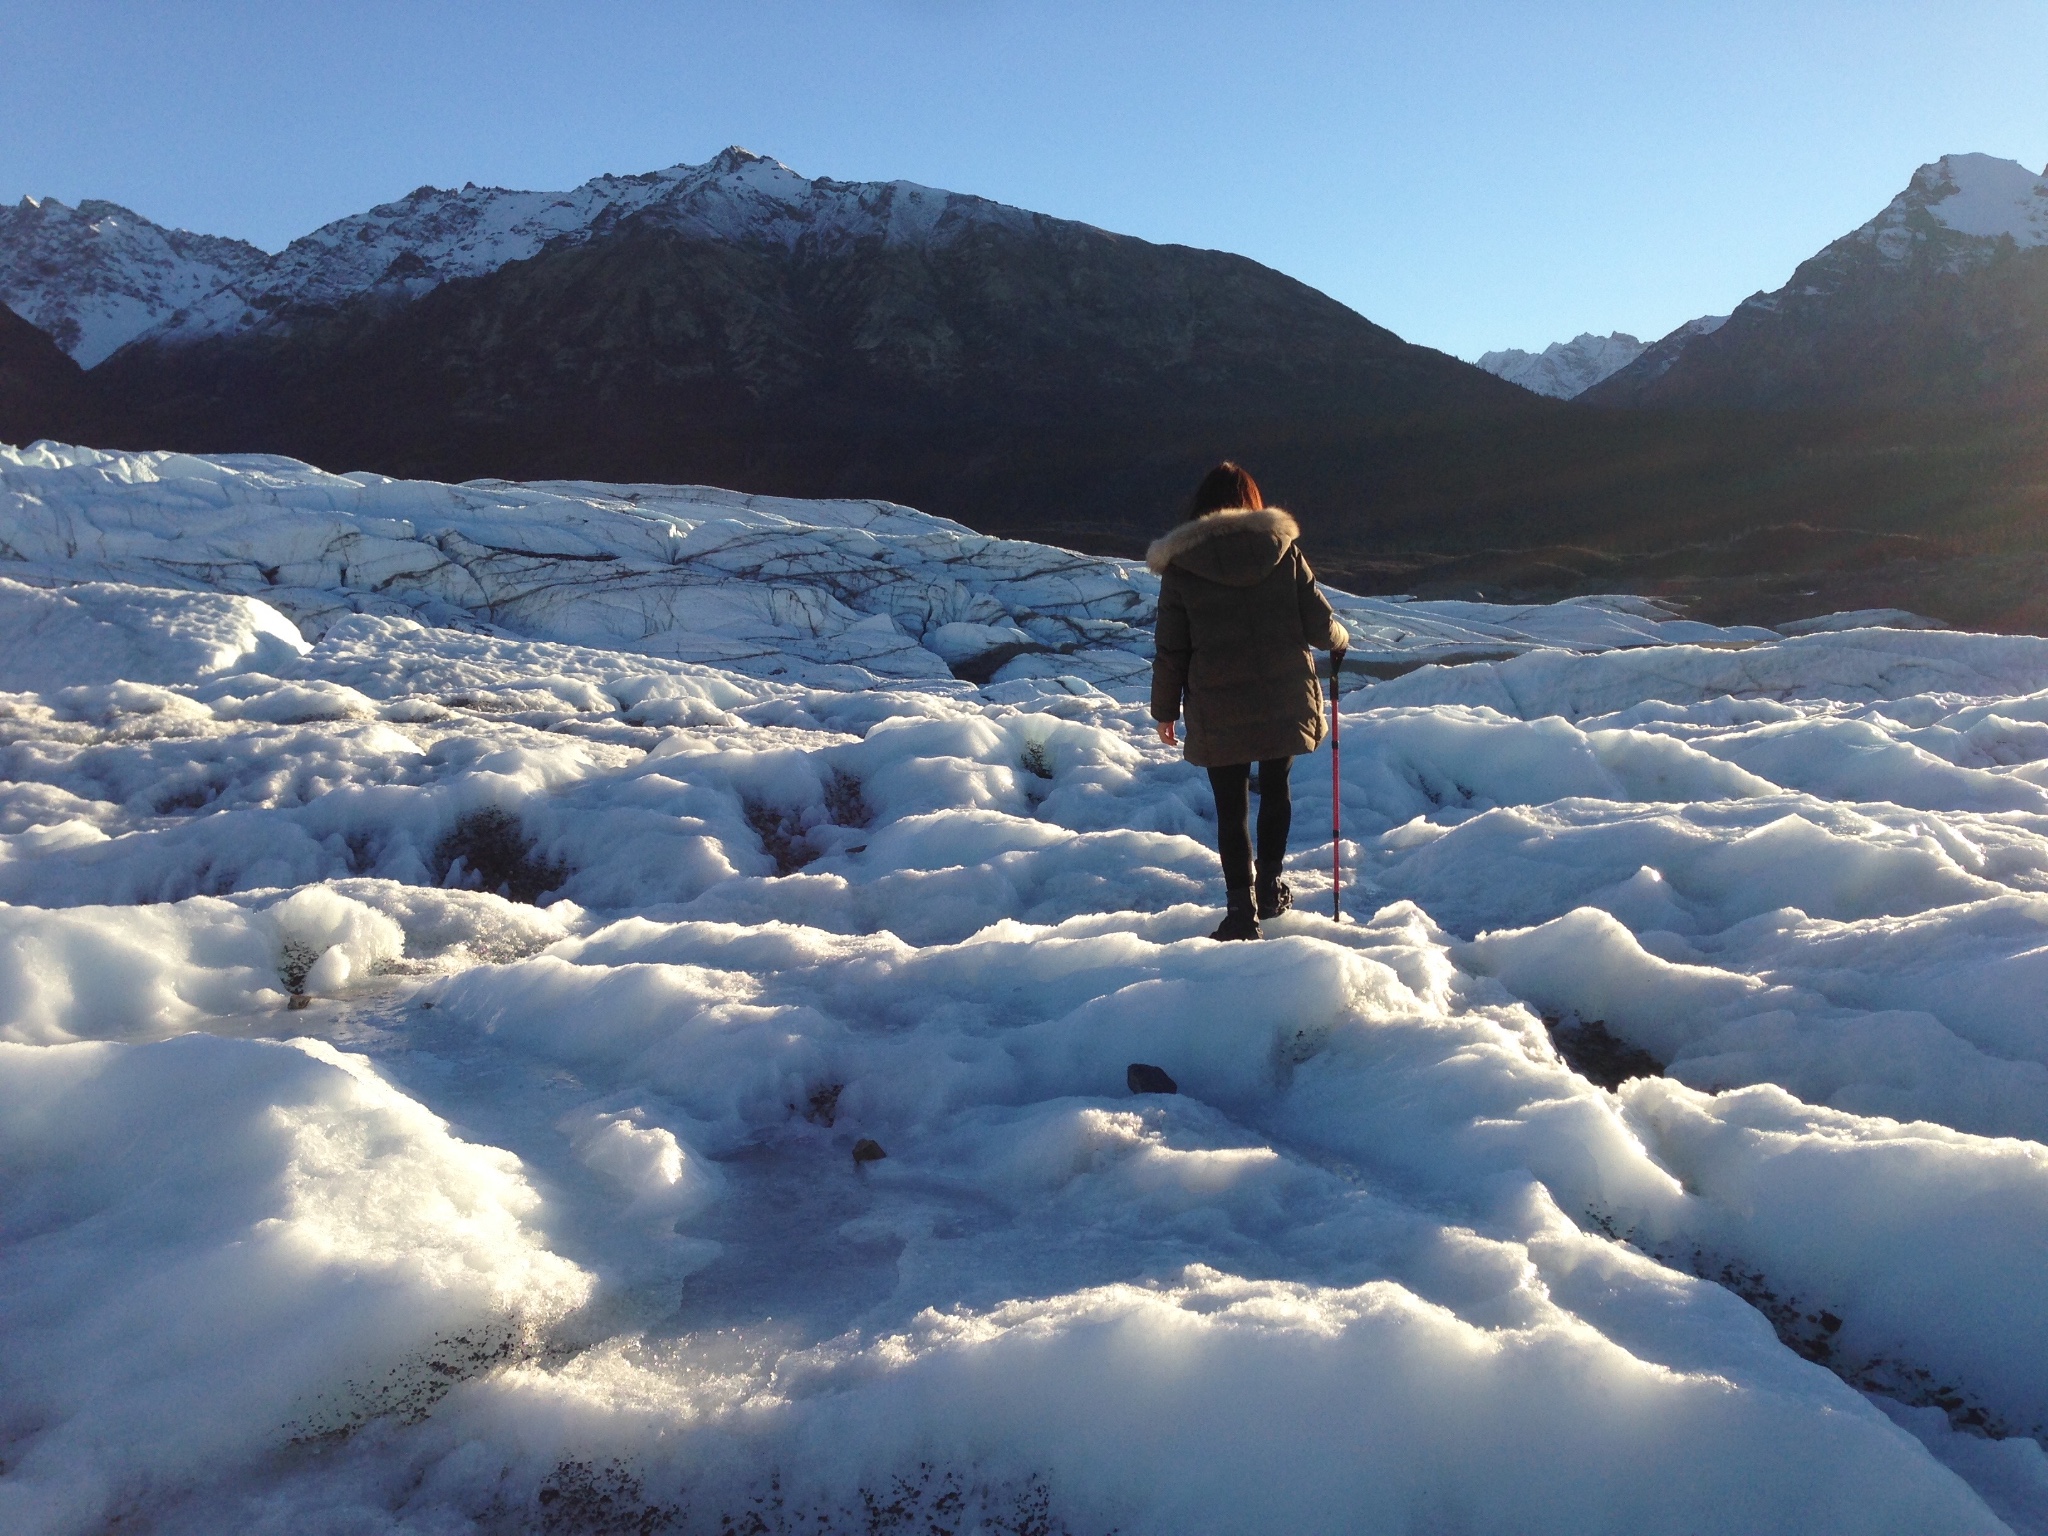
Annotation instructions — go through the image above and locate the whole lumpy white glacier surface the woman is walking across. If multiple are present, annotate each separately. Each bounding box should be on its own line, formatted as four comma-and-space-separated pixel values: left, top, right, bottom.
0, 444, 2048, 1534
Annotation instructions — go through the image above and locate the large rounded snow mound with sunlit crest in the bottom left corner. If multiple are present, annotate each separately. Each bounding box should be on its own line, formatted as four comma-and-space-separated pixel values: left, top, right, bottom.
0, 1034, 590, 1532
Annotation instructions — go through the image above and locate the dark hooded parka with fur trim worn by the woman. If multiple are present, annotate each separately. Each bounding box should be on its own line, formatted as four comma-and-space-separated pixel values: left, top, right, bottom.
1145, 506, 1350, 768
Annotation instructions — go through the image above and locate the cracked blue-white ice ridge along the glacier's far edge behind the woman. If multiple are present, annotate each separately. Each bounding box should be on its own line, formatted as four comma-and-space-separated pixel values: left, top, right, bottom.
0, 442, 1769, 688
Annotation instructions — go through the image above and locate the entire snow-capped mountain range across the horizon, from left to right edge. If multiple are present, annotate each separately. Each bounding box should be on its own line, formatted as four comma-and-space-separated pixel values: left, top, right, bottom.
0, 150, 2048, 623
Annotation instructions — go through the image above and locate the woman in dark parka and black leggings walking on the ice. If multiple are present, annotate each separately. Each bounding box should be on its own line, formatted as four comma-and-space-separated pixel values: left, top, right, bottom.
1145, 463, 1350, 938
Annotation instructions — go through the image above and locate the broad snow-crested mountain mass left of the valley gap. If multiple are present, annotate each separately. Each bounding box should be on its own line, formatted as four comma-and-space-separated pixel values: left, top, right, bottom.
0, 150, 1536, 532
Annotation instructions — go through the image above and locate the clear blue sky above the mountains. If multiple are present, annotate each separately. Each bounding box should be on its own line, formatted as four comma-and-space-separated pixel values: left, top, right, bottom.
0, 0, 2048, 356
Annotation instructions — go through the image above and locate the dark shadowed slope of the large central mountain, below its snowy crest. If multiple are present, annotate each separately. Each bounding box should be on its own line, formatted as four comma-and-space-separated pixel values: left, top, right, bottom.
94, 199, 1559, 528
